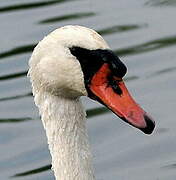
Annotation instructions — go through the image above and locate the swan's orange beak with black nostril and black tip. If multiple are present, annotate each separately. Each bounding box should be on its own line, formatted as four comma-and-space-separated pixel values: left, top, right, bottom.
89, 63, 155, 134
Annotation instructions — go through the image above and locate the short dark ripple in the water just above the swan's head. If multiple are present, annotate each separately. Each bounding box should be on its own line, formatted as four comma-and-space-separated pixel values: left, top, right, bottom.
39, 12, 95, 24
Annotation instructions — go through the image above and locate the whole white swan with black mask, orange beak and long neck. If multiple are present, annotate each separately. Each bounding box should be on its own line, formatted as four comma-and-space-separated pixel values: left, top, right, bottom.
28, 26, 155, 180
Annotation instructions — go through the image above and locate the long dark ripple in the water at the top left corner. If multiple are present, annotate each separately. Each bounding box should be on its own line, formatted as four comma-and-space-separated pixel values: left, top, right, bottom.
0, 0, 72, 13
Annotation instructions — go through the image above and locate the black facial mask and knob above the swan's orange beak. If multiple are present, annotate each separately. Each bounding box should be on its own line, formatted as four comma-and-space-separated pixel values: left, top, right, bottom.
70, 46, 127, 82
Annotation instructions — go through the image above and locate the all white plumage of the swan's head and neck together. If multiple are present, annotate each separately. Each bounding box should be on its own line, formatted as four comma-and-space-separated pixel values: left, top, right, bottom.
28, 26, 109, 180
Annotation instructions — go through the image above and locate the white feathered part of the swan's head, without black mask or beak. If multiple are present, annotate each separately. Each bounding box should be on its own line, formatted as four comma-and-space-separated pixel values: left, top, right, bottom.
29, 26, 109, 98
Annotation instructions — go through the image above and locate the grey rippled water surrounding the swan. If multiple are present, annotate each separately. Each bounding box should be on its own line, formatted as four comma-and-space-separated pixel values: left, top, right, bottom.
0, 0, 176, 180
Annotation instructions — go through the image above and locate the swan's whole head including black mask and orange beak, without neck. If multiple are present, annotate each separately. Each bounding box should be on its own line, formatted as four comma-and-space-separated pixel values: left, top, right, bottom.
29, 26, 155, 134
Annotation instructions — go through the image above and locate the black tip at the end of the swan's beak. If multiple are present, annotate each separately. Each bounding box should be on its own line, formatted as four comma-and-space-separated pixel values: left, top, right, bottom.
140, 115, 155, 134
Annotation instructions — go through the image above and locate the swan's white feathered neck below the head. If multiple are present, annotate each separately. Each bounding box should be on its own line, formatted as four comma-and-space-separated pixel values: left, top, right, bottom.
35, 94, 94, 180
